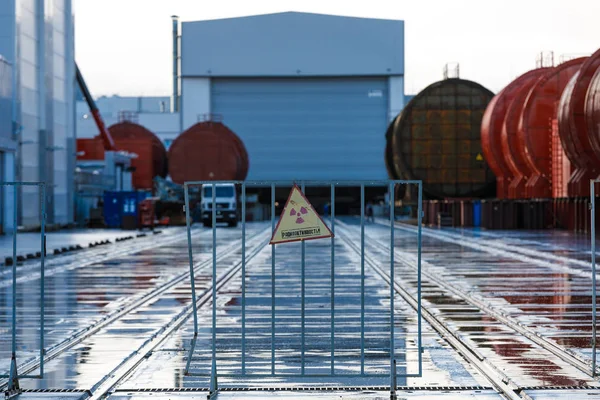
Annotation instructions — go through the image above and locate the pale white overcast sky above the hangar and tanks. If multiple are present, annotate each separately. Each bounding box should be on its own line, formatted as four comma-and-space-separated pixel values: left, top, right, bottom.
73, 0, 600, 97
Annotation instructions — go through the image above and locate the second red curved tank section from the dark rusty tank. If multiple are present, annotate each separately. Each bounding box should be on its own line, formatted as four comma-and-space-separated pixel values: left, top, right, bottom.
500, 68, 547, 199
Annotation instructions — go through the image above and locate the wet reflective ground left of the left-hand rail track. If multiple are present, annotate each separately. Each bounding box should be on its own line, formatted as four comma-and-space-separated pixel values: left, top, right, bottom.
0, 223, 268, 382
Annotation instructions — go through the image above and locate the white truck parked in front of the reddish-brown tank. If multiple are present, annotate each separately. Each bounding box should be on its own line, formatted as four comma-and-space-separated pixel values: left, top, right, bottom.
200, 183, 238, 227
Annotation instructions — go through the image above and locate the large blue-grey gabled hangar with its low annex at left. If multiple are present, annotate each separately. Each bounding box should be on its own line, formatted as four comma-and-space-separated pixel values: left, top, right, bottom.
77, 12, 406, 180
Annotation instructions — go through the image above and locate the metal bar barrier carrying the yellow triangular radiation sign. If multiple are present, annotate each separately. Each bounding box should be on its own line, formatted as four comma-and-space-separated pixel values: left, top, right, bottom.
184, 180, 423, 397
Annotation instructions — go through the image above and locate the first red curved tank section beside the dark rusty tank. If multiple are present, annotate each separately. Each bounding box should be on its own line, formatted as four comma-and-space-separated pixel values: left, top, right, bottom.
481, 68, 546, 199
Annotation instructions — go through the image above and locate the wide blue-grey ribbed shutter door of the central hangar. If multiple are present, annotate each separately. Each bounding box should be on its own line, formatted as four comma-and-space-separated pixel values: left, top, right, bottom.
211, 78, 388, 180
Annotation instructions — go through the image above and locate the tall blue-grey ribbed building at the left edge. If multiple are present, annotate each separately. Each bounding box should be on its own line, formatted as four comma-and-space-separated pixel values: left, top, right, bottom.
0, 0, 75, 231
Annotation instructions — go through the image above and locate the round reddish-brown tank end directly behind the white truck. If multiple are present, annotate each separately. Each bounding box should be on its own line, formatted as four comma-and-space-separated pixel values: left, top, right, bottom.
169, 121, 249, 184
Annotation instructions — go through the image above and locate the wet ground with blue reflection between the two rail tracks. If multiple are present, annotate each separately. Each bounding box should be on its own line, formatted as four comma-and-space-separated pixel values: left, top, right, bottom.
122, 228, 488, 389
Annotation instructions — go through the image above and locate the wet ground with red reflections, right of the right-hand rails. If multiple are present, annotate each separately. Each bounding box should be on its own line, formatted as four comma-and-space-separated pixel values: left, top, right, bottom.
360, 220, 595, 386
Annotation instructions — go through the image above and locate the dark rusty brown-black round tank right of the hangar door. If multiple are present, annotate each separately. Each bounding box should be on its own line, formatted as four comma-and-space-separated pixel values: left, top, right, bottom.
386, 78, 495, 198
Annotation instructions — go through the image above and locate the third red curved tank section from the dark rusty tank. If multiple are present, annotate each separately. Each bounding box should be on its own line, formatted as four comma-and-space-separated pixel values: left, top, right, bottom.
517, 57, 586, 198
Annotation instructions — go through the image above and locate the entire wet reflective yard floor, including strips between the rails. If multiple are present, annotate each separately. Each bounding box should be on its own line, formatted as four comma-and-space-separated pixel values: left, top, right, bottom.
0, 219, 597, 399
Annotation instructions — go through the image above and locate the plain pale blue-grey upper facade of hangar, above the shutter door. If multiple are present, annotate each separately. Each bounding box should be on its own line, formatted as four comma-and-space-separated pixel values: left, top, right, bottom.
181, 12, 404, 77
